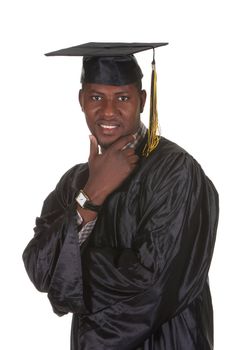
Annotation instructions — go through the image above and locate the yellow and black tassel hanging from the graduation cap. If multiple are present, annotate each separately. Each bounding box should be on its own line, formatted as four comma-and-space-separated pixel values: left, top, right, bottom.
142, 50, 160, 157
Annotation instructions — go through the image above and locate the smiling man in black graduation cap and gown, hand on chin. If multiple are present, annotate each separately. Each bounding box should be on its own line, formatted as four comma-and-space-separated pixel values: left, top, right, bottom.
23, 43, 218, 350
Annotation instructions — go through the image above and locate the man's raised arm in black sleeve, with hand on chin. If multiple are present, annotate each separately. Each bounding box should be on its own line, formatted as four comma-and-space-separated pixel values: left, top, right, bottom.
23, 136, 138, 315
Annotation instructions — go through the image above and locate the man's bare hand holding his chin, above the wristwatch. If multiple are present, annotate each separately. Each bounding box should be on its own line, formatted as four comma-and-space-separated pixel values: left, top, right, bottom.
84, 135, 139, 205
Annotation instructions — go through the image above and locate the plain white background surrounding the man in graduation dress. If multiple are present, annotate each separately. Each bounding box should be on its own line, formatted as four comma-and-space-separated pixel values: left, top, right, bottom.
0, 0, 233, 350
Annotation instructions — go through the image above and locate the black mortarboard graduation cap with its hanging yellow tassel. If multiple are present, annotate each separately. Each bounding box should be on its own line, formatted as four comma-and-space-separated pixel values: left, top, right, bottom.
45, 42, 168, 156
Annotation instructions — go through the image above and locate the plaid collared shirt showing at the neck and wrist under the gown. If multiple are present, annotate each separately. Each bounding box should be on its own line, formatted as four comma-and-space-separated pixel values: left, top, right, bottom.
77, 121, 147, 245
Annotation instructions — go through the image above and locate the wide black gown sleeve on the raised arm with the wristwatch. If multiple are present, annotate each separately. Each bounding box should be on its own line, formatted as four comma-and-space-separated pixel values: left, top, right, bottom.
23, 165, 87, 316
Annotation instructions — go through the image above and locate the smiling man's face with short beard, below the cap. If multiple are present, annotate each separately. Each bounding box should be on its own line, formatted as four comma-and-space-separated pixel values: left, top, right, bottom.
79, 84, 146, 148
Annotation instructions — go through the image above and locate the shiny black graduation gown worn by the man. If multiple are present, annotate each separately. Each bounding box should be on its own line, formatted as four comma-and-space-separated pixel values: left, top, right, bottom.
23, 138, 218, 350
